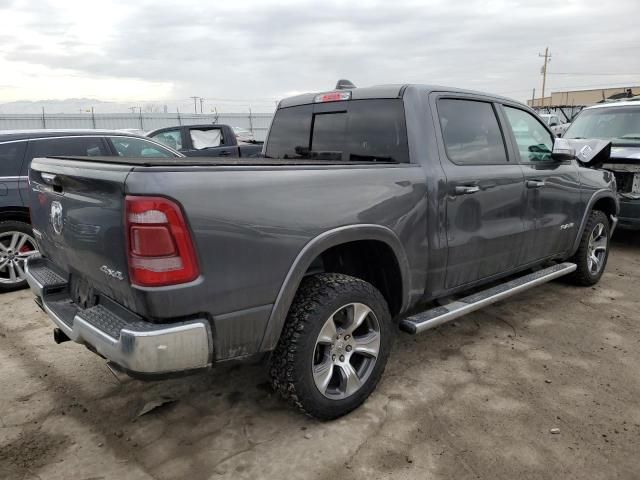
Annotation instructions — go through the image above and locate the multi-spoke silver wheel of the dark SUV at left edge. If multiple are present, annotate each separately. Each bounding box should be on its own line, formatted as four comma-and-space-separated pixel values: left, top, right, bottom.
0, 220, 38, 292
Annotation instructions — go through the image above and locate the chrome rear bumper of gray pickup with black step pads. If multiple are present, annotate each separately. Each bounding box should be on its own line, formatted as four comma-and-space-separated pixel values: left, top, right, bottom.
26, 258, 213, 375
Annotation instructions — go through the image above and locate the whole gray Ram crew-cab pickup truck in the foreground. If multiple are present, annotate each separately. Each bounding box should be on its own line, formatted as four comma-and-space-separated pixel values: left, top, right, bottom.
27, 85, 619, 419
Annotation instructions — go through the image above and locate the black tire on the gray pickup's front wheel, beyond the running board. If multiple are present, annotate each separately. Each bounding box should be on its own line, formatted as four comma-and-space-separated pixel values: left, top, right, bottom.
566, 210, 611, 287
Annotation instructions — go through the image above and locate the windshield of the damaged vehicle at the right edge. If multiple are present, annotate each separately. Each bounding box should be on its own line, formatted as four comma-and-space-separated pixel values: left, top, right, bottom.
564, 105, 640, 145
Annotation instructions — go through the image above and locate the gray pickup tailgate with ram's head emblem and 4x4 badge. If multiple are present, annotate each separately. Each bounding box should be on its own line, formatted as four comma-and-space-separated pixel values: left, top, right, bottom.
29, 158, 134, 307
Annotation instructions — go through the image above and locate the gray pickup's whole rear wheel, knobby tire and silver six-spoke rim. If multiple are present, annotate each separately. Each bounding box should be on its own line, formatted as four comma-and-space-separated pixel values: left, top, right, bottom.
270, 273, 394, 420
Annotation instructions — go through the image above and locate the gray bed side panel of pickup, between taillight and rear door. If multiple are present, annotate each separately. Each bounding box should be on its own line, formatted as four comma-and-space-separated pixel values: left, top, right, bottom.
126, 164, 427, 355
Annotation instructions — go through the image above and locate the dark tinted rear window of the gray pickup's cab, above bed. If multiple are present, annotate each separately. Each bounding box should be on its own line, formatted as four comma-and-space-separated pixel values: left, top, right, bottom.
265, 99, 409, 163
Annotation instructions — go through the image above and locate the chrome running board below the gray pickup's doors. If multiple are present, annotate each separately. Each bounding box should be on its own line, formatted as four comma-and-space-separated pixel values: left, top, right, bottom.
400, 262, 577, 334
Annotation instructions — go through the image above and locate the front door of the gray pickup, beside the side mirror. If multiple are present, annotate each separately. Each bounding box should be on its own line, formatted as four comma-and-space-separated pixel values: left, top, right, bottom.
502, 105, 584, 263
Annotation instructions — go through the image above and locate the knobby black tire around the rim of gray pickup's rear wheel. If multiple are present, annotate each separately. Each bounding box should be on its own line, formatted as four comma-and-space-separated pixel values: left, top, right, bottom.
269, 273, 395, 420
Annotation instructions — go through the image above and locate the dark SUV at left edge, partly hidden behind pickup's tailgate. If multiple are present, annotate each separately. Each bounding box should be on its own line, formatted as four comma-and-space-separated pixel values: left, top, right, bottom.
0, 130, 184, 292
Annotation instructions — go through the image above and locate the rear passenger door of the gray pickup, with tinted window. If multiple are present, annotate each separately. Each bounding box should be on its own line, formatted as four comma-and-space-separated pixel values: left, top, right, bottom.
431, 95, 526, 289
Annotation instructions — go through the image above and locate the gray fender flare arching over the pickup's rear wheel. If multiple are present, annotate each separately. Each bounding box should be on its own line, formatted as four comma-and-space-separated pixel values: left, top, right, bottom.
260, 224, 411, 351
